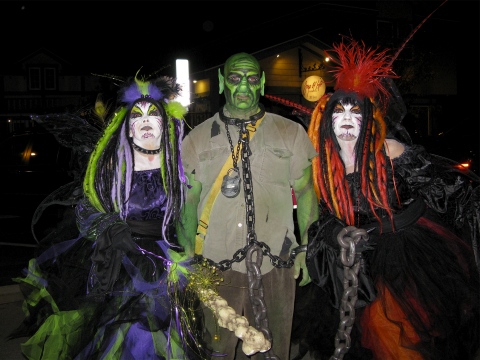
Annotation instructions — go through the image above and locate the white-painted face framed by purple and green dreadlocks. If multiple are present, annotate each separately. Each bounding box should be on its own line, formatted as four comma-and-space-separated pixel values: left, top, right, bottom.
129, 101, 162, 150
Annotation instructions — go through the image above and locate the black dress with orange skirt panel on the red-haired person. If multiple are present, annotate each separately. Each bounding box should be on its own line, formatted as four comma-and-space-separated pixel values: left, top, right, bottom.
292, 145, 480, 360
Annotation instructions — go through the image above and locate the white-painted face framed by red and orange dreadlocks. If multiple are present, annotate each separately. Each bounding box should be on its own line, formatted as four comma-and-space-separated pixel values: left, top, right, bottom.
332, 102, 362, 141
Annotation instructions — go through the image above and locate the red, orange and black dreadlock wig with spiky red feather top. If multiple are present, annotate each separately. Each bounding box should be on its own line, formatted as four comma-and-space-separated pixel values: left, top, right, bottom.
308, 40, 398, 225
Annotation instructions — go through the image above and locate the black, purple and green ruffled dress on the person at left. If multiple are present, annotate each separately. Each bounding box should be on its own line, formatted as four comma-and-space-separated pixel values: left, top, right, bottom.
14, 169, 201, 359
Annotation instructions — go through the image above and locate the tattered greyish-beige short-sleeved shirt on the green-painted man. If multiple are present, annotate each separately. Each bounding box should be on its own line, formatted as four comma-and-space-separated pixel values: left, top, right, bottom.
182, 112, 317, 273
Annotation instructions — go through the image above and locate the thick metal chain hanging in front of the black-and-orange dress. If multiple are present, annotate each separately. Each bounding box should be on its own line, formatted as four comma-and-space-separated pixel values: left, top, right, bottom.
330, 226, 368, 360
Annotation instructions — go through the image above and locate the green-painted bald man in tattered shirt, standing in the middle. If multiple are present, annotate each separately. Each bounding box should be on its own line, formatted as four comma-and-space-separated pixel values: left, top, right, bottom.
178, 52, 318, 359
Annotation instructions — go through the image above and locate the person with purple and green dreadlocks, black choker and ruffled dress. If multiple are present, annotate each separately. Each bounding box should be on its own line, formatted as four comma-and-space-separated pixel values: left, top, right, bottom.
7, 74, 206, 359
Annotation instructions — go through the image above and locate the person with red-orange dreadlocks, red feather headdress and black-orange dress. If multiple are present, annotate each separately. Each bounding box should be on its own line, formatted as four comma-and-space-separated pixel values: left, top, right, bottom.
290, 39, 480, 360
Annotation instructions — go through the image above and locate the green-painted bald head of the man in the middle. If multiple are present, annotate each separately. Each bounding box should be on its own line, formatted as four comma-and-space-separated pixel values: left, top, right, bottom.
220, 53, 265, 115
